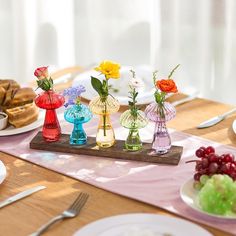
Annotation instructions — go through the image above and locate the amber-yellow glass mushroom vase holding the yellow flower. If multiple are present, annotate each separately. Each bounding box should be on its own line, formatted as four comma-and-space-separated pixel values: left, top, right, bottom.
89, 95, 120, 148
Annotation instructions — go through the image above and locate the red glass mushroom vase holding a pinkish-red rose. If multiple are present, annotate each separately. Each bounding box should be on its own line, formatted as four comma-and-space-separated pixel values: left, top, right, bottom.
35, 90, 65, 142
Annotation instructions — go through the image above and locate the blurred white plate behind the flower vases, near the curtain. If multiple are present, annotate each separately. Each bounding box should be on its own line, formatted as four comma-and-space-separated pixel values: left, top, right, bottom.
73, 65, 155, 105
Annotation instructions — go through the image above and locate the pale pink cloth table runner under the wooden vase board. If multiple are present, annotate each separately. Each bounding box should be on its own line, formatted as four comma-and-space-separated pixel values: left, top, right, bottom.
0, 114, 236, 235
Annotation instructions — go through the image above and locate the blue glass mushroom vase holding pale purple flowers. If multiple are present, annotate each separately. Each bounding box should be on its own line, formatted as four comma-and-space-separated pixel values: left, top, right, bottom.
64, 104, 93, 145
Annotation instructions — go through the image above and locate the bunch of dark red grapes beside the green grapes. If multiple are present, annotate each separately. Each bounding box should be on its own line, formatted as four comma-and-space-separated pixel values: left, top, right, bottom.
191, 146, 236, 181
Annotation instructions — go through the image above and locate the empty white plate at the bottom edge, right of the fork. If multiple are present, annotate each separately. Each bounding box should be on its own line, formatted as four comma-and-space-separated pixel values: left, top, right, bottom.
74, 213, 212, 236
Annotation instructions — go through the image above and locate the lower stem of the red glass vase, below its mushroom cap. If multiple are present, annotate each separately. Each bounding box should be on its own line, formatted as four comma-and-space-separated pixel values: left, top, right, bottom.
42, 109, 61, 142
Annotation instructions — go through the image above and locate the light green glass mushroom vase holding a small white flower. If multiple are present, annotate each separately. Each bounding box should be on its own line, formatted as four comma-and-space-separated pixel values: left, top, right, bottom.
120, 110, 148, 151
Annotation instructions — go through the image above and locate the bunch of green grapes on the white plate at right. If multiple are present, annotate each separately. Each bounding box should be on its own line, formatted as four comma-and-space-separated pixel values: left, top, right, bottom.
198, 174, 236, 215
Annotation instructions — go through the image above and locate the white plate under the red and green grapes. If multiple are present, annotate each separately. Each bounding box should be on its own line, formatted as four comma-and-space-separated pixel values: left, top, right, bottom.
180, 179, 236, 219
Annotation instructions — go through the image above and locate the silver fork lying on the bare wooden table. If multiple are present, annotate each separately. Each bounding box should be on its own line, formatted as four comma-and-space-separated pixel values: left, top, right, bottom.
30, 193, 89, 236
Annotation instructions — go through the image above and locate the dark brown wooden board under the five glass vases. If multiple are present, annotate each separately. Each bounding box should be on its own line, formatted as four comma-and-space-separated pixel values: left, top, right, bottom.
30, 132, 183, 165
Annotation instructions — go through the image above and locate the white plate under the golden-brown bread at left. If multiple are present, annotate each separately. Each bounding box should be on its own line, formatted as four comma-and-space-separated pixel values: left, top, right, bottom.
0, 111, 44, 137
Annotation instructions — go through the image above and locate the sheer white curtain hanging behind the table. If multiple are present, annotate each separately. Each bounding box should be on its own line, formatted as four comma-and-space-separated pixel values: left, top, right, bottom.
0, 0, 236, 104
